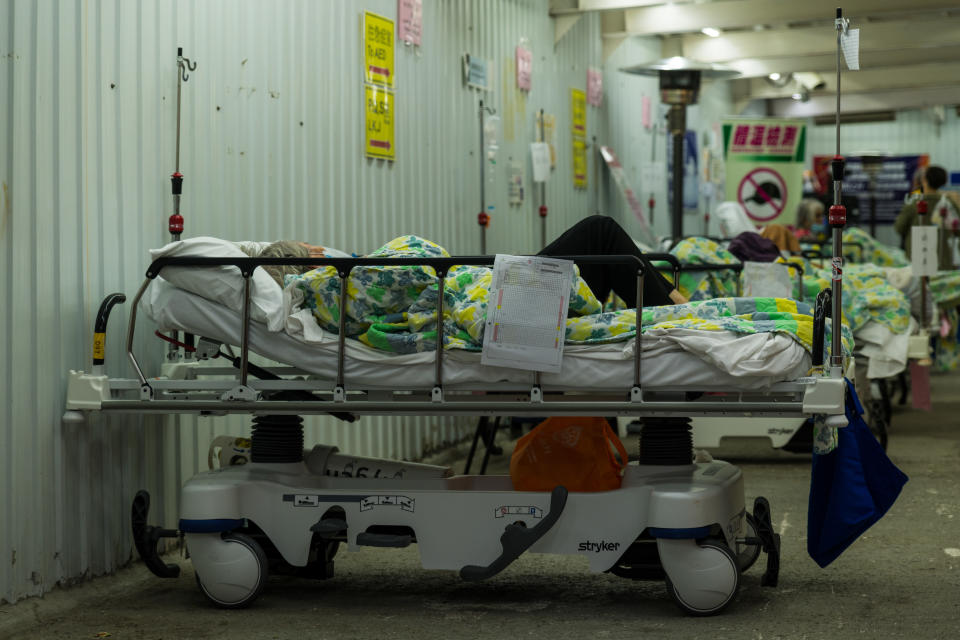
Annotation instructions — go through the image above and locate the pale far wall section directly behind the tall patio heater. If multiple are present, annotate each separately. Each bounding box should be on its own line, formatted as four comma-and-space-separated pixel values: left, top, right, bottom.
604, 37, 733, 237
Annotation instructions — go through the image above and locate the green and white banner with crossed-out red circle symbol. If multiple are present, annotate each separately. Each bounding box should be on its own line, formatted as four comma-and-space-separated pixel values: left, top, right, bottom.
723, 118, 807, 226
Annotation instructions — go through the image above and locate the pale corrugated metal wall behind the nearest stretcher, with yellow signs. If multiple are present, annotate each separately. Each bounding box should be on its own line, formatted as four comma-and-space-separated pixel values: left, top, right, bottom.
0, 0, 605, 601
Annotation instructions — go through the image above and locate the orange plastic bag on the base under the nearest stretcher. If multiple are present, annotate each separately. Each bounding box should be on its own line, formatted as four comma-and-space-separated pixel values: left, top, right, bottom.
510, 417, 627, 491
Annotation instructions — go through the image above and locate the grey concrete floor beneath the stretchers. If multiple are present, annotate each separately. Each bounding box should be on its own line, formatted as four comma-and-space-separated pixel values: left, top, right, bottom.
0, 375, 960, 640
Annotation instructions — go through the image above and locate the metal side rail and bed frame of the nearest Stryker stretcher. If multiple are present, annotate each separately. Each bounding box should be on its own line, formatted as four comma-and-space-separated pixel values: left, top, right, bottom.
67, 255, 844, 417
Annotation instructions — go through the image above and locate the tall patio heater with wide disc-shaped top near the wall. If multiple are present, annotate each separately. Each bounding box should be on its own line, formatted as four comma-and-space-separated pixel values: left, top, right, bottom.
620, 56, 740, 243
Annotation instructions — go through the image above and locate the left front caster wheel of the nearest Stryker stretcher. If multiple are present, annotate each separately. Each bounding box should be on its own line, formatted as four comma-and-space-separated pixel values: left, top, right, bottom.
194, 533, 267, 609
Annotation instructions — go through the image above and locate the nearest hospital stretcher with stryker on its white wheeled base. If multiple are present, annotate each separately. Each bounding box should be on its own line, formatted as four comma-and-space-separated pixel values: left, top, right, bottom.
67, 251, 846, 615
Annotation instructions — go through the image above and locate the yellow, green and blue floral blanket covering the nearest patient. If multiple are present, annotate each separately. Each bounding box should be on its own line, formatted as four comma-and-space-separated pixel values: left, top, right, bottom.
285, 236, 853, 353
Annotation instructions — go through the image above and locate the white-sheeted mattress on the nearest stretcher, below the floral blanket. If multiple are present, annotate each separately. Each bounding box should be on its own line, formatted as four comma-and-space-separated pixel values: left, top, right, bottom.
140, 278, 810, 390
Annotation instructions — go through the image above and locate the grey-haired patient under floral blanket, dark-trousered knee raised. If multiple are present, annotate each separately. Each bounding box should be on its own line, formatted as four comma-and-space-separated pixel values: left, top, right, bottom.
246, 216, 840, 353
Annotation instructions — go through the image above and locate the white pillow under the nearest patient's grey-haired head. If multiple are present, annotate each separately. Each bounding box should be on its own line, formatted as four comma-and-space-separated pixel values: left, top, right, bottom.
150, 236, 284, 331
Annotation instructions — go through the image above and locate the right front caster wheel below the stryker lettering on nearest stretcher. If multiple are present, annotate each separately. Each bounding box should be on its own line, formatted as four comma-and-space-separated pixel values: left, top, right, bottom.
666, 543, 740, 616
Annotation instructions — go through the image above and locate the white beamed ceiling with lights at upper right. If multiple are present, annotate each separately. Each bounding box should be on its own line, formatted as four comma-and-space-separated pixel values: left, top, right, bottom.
550, 0, 960, 116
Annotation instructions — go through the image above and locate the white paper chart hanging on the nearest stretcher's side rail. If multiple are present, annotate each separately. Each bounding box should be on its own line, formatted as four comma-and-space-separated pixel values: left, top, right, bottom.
480, 254, 573, 373
